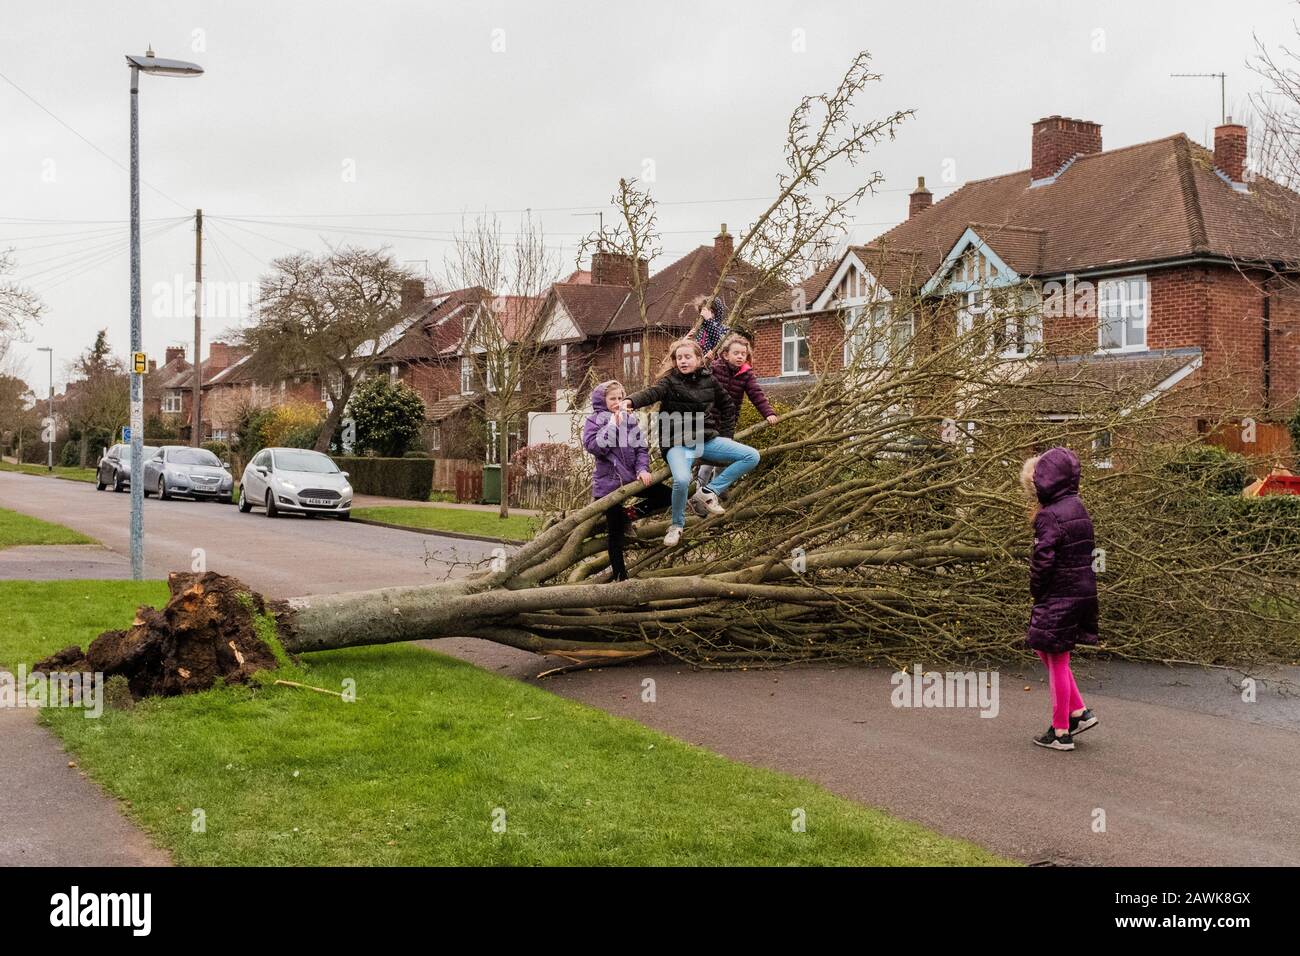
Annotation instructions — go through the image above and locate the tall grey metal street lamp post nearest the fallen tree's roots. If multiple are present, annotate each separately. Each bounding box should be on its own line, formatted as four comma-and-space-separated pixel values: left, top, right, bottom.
126, 49, 203, 580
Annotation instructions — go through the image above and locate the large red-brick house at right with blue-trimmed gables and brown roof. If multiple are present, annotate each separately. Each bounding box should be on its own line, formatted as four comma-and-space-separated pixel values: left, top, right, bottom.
755, 116, 1300, 437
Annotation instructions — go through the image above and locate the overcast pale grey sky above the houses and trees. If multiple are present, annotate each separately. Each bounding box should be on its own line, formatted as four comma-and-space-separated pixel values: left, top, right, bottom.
0, 0, 1297, 393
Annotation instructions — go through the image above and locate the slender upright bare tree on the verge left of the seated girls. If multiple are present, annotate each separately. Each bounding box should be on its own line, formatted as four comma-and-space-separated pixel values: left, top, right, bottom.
449, 215, 559, 518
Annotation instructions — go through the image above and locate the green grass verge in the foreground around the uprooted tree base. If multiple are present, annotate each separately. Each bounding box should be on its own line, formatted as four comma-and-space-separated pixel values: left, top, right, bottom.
12, 581, 1005, 865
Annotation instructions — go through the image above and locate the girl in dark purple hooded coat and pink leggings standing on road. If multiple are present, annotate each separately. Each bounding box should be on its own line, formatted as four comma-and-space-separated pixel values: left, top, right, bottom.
1021, 447, 1097, 750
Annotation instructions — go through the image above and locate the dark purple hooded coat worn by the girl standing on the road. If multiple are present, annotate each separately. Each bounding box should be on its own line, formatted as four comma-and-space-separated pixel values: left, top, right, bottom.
1024, 447, 1097, 654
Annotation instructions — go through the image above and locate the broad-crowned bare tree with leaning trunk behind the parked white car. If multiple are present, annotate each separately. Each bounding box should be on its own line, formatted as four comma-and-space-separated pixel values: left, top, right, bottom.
241, 246, 411, 451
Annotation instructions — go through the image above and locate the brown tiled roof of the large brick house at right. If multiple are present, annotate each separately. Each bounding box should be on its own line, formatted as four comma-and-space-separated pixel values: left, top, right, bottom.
872, 134, 1300, 276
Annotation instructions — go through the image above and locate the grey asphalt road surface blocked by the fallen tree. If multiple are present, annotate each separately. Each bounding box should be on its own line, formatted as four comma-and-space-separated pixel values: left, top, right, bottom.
0, 472, 1300, 865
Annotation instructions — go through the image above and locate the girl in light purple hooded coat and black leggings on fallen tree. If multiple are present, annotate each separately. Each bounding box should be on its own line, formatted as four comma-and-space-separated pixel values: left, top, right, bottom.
582, 381, 672, 581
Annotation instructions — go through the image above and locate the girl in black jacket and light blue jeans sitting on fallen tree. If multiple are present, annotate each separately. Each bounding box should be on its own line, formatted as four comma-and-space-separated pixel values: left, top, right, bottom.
624, 338, 758, 548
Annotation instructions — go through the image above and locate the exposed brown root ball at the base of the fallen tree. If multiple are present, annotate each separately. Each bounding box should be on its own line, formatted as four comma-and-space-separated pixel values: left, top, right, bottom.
36, 571, 276, 698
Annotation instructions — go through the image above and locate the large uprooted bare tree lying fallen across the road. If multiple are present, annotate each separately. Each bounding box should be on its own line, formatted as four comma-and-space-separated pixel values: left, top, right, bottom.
38, 57, 1300, 695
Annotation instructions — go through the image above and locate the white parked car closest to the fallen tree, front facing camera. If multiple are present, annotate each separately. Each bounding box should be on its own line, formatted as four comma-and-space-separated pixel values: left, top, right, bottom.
239, 449, 352, 522
